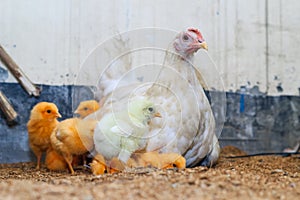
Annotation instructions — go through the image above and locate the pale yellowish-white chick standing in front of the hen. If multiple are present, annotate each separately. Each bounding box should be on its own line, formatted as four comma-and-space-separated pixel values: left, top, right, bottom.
94, 99, 161, 166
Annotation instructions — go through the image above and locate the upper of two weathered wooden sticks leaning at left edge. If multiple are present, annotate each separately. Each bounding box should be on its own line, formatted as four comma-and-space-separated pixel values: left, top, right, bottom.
0, 45, 41, 97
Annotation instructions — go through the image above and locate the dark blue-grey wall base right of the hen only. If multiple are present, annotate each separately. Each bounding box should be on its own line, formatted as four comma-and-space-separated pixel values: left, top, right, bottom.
220, 93, 300, 154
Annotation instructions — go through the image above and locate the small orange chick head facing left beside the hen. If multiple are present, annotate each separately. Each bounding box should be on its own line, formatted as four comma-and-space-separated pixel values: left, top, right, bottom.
74, 100, 100, 119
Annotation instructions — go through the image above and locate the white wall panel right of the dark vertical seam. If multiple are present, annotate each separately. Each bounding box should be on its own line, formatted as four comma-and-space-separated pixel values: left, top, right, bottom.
268, 0, 300, 95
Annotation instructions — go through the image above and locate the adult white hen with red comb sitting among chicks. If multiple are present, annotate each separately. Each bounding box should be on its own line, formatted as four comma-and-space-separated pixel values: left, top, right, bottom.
90, 28, 220, 167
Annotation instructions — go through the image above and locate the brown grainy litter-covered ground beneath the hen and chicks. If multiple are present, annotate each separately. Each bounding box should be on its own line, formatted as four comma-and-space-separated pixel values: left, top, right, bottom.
0, 147, 300, 200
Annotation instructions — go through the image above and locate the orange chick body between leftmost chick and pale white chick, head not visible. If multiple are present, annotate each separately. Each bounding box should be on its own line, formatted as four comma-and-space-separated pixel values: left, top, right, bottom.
50, 118, 96, 174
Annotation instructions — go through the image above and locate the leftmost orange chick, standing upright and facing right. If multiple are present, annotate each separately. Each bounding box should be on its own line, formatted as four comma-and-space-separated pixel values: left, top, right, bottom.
27, 102, 61, 169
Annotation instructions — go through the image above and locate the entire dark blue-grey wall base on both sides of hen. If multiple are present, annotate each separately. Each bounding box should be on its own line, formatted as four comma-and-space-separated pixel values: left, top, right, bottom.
0, 83, 300, 163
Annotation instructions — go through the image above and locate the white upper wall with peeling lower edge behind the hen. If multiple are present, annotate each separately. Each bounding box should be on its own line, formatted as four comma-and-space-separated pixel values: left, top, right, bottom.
0, 0, 300, 95
